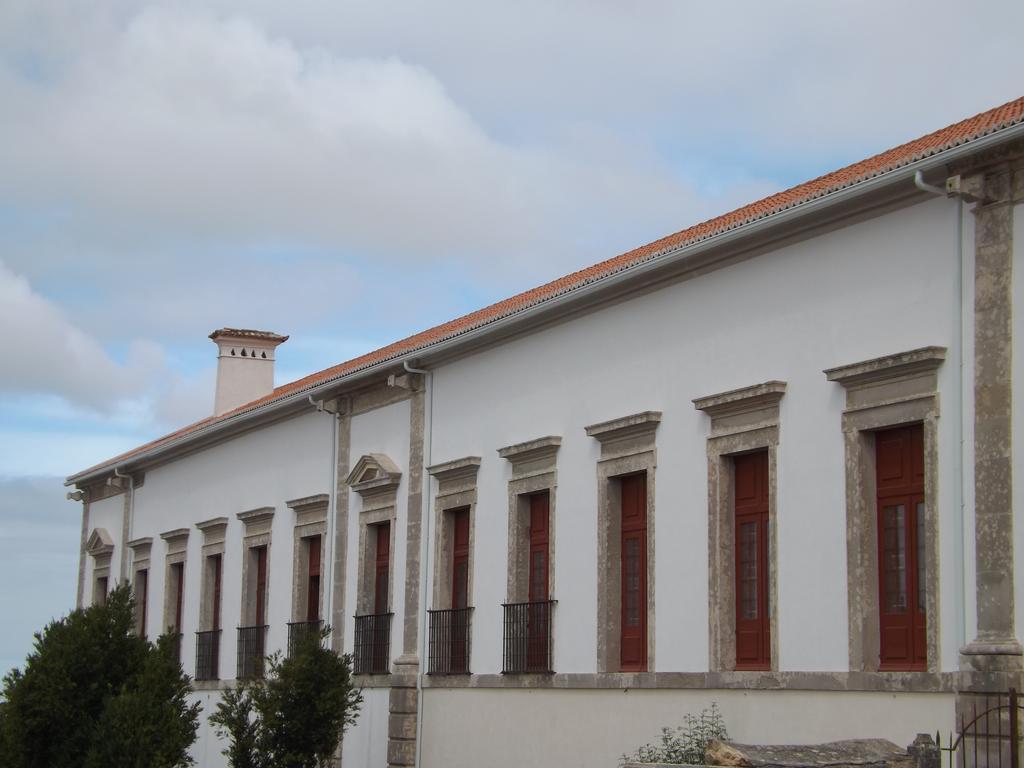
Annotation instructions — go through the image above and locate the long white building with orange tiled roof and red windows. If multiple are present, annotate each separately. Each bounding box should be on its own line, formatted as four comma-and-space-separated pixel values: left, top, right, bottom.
69, 98, 1024, 767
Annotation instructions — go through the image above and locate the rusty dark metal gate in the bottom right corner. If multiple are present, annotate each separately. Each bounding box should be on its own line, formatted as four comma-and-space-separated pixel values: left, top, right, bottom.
935, 688, 1024, 768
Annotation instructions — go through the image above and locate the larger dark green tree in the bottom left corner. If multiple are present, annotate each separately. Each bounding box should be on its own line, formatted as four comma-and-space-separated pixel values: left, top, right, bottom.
0, 585, 200, 768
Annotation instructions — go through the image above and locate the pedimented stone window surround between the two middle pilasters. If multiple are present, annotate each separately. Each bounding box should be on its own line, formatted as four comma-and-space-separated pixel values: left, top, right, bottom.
346, 454, 401, 615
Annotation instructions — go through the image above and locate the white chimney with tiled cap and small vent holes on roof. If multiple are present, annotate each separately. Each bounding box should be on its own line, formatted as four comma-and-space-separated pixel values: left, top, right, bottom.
210, 328, 288, 416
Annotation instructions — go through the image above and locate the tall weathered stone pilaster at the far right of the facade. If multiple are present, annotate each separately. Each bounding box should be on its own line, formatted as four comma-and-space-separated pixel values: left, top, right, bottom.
947, 153, 1024, 689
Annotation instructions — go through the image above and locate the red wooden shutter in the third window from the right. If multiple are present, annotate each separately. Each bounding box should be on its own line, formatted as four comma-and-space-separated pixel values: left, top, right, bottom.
618, 473, 647, 672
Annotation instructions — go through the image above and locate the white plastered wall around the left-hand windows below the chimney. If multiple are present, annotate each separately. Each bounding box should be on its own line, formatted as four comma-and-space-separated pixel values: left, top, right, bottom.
126, 412, 334, 765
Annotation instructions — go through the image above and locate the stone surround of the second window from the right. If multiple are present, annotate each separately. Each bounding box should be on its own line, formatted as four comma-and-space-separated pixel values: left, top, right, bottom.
693, 381, 785, 676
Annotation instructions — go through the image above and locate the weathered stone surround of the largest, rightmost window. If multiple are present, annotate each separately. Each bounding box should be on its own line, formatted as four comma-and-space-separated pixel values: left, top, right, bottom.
824, 346, 946, 675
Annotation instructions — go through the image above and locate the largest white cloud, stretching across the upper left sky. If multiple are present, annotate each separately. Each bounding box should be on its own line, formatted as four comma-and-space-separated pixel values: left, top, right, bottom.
0, 7, 720, 274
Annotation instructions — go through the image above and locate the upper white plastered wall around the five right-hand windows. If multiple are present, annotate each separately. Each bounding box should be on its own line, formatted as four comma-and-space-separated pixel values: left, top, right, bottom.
425, 193, 958, 674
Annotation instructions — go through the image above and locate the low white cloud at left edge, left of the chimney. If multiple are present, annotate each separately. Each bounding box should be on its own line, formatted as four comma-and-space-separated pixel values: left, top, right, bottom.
0, 261, 215, 442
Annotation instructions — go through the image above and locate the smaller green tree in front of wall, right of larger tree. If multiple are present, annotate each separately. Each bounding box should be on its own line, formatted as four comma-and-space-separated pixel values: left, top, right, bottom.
210, 630, 362, 768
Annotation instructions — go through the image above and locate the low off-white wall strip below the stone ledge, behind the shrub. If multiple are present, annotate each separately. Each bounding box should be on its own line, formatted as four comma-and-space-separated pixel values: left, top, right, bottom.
419, 688, 953, 768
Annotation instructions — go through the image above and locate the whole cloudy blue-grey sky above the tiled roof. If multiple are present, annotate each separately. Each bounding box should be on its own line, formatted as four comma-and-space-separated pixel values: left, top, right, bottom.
0, 0, 1024, 672
